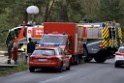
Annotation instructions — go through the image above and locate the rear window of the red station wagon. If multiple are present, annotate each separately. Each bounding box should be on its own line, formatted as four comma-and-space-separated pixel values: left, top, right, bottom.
33, 49, 55, 56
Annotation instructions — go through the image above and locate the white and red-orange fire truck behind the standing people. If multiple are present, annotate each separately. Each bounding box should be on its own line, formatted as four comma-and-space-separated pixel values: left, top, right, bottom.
6, 25, 44, 46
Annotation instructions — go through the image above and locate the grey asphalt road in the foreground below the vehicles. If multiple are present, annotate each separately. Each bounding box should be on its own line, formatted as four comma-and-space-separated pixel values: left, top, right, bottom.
0, 60, 124, 83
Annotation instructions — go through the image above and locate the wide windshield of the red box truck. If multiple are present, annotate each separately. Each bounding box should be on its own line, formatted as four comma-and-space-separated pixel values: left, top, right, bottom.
41, 36, 66, 45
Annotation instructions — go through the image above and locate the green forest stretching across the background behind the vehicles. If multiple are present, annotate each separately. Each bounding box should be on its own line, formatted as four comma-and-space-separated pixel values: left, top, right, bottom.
0, 0, 124, 48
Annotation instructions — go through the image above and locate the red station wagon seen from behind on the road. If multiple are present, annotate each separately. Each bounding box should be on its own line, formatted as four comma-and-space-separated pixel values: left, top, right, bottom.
29, 46, 70, 72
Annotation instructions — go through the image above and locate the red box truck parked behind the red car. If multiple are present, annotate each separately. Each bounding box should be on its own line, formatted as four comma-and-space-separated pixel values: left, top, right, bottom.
40, 22, 84, 64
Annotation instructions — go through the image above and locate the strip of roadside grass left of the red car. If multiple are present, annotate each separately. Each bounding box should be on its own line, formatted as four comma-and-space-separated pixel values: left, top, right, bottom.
0, 63, 28, 77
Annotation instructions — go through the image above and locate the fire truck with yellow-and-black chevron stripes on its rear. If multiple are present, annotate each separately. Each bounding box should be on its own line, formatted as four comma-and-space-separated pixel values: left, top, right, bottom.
77, 21, 122, 63
